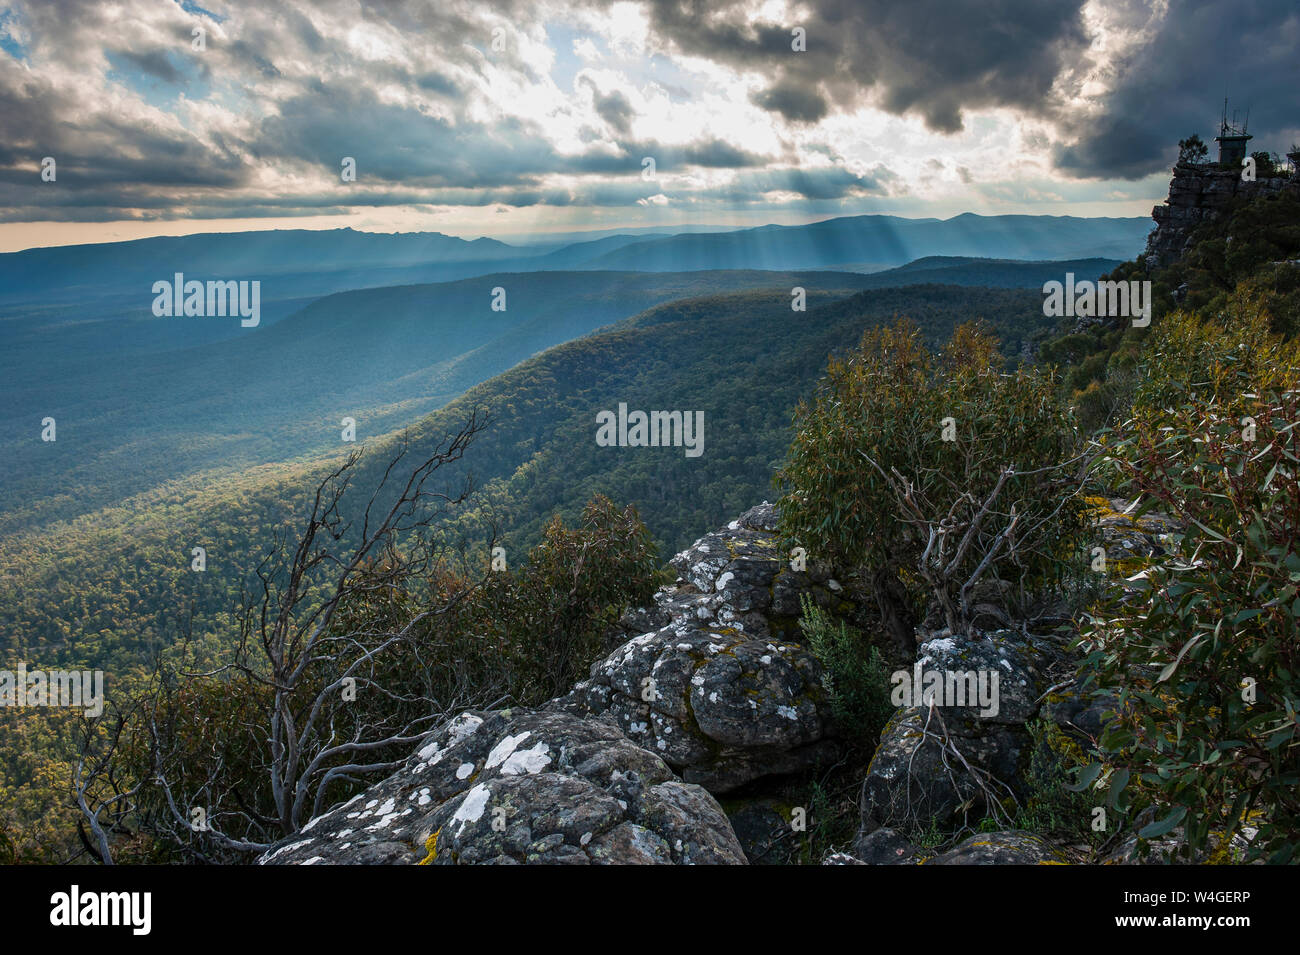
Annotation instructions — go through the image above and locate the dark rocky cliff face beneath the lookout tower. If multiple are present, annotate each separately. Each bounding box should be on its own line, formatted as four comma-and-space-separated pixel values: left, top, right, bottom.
1147, 162, 1296, 269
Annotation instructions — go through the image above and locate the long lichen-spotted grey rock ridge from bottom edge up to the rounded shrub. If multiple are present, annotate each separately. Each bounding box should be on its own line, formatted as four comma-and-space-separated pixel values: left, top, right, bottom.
259, 504, 853, 864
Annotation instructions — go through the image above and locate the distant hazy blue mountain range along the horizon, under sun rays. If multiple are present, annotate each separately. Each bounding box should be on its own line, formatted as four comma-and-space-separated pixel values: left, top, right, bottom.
0, 213, 1151, 307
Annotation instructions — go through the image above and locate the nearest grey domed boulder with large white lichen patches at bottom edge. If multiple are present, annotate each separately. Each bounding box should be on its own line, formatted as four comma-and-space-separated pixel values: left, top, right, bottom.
259, 709, 746, 865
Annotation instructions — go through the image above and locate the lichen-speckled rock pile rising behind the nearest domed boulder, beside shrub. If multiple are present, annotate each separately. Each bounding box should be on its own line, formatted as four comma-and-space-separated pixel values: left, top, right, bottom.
547, 503, 849, 793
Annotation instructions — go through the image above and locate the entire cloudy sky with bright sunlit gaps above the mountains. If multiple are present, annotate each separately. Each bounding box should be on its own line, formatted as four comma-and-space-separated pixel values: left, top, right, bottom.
0, 0, 1300, 251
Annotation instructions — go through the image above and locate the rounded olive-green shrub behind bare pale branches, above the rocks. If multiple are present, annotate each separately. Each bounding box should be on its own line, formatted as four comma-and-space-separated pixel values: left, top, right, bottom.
776, 322, 1082, 646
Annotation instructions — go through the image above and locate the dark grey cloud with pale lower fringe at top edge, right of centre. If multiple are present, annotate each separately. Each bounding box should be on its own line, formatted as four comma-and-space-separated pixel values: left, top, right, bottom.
605, 0, 1088, 133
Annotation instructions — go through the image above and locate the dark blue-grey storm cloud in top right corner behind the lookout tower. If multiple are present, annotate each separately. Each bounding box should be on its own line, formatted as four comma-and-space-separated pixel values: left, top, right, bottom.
1054, 0, 1300, 178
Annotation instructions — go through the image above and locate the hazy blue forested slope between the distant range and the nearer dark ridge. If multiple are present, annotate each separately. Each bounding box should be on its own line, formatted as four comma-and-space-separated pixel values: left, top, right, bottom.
0, 272, 883, 533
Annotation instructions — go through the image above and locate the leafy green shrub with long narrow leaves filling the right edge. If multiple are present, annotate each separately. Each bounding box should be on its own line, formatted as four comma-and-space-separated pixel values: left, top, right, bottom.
1086, 317, 1300, 861
